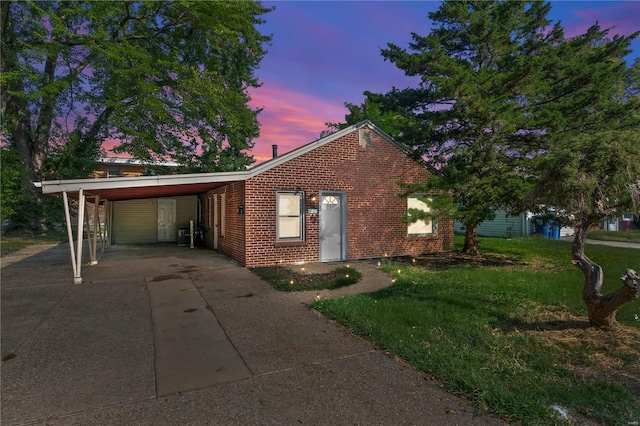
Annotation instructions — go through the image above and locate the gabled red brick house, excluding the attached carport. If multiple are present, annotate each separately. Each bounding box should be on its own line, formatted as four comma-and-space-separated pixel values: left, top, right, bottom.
200, 122, 453, 267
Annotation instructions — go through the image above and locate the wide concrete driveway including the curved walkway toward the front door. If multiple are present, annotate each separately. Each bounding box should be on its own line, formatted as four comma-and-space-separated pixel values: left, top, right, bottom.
0, 245, 504, 425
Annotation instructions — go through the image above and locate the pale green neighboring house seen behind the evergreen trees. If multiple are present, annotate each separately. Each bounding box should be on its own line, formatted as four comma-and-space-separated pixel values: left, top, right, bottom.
454, 210, 574, 238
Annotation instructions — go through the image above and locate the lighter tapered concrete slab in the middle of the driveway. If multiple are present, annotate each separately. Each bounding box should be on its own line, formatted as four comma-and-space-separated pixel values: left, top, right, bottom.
146, 275, 251, 396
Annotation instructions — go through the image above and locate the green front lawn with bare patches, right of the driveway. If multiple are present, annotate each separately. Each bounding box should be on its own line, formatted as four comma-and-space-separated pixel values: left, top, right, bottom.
313, 238, 640, 426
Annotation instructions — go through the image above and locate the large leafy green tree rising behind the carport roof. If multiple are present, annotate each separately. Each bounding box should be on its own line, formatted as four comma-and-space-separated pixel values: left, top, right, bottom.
0, 0, 270, 226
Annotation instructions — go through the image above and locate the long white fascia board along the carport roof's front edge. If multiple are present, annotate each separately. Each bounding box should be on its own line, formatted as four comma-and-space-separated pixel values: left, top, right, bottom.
34, 171, 247, 194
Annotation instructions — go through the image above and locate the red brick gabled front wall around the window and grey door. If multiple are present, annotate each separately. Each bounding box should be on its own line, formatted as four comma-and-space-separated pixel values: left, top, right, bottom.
241, 130, 453, 267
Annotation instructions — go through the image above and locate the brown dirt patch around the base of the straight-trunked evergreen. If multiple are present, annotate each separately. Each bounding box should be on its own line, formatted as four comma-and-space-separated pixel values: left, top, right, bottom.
405, 251, 525, 270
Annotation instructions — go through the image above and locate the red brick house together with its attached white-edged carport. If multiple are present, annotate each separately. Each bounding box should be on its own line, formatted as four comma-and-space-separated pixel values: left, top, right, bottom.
39, 121, 453, 282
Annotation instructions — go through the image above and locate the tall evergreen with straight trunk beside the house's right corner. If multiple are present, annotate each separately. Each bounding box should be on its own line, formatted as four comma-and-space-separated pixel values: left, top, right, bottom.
376, 1, 562, 253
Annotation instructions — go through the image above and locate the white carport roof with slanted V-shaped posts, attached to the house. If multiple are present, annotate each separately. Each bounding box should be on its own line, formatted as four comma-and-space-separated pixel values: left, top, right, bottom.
35, 172, 246, 284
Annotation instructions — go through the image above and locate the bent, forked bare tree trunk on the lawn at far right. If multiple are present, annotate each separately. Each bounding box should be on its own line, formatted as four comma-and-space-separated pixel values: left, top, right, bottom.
572, 223, 640, 328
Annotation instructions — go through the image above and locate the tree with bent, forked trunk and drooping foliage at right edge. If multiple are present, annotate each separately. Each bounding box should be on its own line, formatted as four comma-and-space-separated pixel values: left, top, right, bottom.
525, 25, 640, 327
